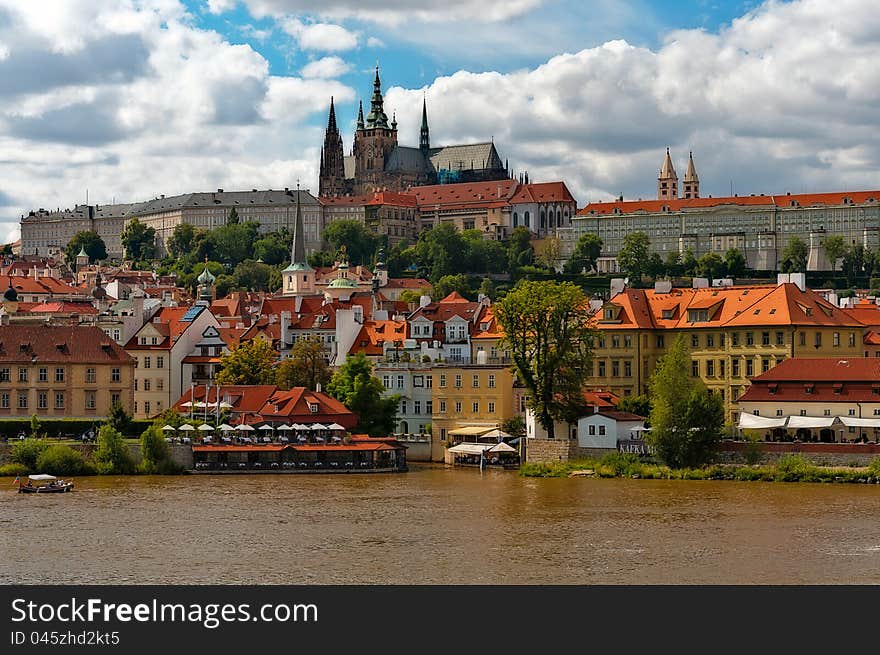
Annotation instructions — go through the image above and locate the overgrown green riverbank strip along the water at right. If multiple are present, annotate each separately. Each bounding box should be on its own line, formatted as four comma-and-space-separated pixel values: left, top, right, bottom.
520, 453, 880, 484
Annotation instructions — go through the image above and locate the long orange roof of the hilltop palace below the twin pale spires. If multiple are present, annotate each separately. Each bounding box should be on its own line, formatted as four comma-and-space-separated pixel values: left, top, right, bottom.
578, 191, 880, 216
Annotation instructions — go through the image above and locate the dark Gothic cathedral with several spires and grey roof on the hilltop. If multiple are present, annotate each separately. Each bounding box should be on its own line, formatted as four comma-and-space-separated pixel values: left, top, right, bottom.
318, 66, 510, 197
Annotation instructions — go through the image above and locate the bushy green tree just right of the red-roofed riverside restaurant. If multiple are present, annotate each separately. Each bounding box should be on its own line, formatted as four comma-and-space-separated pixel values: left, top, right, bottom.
327, 353, 400, 436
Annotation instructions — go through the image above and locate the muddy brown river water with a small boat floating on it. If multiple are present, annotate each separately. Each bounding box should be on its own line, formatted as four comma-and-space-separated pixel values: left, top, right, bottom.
0, 465, 880, 584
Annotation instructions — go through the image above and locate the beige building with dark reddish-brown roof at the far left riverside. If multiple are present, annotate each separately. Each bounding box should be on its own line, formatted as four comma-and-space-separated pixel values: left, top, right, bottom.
0, 325, 135, 420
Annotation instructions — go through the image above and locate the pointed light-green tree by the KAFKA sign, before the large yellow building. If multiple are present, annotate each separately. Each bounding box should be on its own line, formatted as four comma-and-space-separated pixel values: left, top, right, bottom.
646, 335, 724, 468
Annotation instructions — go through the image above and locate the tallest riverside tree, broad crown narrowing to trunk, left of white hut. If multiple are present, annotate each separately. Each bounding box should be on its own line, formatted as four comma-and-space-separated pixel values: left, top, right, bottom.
494, 280, 593, 439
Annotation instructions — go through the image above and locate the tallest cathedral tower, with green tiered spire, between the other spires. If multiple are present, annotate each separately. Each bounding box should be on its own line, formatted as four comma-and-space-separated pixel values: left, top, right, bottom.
352, 65, 397, 194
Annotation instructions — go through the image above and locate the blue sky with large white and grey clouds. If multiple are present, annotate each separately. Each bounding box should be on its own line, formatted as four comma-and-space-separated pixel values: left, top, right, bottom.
0, 0, 880, 243
